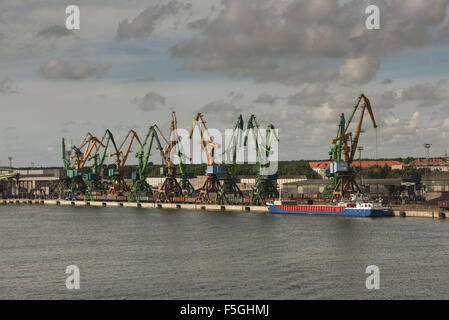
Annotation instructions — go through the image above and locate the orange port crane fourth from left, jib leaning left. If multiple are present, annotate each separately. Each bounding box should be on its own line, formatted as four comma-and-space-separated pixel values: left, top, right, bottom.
189, 113, 226, 203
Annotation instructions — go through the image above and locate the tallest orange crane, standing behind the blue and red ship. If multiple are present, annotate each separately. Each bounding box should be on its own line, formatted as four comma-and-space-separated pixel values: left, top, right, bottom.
330, 94, 377, 203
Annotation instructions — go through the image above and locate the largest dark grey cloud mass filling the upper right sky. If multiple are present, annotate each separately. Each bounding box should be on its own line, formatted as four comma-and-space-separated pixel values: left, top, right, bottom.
170, 0, 448, 85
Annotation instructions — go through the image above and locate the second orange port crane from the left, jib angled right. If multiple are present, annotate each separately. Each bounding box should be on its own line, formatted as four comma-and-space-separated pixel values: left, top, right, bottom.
108, 129, 142, 195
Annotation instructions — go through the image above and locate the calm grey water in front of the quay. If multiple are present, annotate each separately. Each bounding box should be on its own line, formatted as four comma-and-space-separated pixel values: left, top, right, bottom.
0, 205, 449, 299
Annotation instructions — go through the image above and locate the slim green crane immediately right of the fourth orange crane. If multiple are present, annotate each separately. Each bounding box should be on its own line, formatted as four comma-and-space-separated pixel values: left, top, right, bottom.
215, 115, 244, 204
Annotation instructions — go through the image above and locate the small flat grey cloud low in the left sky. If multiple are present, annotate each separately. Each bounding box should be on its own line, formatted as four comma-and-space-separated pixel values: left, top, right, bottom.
39, 59, 111, 80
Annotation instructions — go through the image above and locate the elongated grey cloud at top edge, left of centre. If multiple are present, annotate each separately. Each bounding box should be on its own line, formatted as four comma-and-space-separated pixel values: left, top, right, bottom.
116, 0, 191, 40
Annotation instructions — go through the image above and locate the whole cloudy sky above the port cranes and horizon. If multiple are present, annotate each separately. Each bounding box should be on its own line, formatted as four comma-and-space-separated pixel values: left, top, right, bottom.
0, 0, 449, 166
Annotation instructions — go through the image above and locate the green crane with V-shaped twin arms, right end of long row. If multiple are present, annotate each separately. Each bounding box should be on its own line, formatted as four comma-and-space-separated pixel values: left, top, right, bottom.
243, 114, 279, 205
